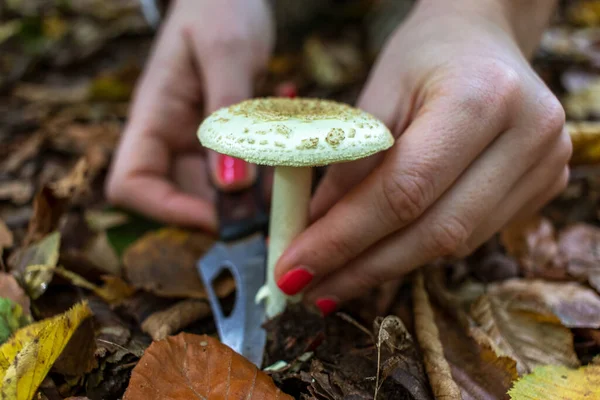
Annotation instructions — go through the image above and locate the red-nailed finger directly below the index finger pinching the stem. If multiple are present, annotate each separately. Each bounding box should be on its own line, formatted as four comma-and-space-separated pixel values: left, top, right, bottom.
307, 115, 560, 311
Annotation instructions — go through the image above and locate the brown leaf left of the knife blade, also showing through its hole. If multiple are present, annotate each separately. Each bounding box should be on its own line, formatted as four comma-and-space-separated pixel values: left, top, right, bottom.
123, 228, 235, 299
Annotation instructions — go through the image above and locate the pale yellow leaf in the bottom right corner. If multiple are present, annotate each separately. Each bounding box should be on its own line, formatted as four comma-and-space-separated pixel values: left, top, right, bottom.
508, 365, 600, 400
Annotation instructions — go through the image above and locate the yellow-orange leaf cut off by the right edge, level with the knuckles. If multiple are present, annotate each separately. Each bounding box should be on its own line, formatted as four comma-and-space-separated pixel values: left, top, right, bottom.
565, 121, 600, 165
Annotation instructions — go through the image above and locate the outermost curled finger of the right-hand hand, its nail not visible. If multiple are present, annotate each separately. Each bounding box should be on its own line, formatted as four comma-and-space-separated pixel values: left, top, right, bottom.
456, 132, 572, 257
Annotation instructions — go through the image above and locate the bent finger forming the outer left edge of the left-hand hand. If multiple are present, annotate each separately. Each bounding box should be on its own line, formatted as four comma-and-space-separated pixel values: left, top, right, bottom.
106, 7, 216, 230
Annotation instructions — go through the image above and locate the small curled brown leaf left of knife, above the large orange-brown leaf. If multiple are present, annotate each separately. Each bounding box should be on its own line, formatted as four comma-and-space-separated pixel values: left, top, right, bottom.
142, 299, 211, 340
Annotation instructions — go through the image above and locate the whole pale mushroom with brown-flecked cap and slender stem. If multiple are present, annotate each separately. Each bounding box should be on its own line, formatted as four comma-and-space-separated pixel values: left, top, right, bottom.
198, 97, 394, 318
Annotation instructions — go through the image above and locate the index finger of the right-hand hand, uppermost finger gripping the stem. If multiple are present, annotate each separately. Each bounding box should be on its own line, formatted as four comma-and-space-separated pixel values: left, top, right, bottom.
275, 76, 516, 292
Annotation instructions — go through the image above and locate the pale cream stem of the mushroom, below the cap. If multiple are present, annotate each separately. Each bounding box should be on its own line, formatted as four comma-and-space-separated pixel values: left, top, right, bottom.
257, 166, 312, 318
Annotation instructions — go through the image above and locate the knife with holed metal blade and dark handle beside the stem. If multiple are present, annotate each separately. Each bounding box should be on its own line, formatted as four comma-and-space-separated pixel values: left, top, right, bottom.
197, 162, 269, 368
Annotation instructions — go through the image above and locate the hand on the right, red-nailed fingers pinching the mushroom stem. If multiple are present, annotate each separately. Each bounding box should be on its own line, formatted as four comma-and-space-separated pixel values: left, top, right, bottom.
275, 0, 571, 314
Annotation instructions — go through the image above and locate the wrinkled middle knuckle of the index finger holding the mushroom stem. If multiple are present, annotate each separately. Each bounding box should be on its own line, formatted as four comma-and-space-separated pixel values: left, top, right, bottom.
382, 171, 434, 225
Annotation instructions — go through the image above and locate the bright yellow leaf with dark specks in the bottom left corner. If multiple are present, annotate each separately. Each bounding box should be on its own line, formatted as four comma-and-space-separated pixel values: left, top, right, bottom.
0, 302, 92, 400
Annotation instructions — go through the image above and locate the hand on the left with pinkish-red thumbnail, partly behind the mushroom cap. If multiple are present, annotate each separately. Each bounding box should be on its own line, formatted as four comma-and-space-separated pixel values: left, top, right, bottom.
106, 0, 273, 230
